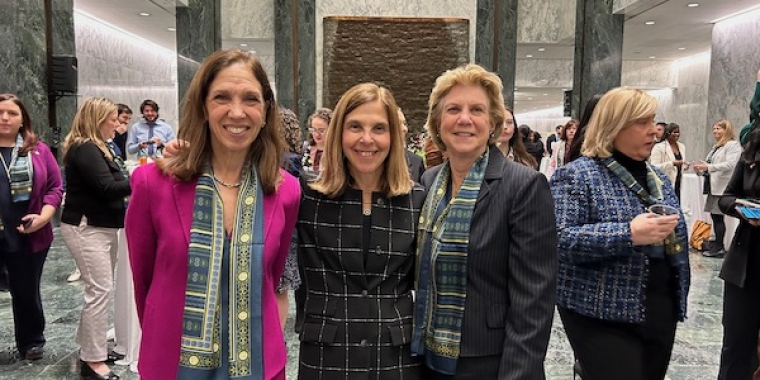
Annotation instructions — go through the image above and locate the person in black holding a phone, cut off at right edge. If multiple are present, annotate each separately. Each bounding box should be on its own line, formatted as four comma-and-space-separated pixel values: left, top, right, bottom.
718, 128, 760, 379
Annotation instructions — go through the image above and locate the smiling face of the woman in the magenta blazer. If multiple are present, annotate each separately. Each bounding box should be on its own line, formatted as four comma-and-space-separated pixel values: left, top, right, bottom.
205, 63, 268, 155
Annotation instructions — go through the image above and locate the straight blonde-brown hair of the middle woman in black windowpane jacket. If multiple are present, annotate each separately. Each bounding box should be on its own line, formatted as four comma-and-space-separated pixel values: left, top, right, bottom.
310, 83, 413, 198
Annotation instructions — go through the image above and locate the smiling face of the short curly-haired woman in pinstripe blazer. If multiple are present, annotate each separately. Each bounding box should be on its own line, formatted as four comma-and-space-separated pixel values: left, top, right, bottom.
439, 85, 495, 163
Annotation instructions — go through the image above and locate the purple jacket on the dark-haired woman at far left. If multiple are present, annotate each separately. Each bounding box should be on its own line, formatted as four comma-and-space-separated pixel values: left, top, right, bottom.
27, 141, 63, 252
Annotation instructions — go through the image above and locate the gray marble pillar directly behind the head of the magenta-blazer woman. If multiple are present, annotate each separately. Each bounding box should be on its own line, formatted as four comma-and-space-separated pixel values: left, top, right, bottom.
176, 0, 222, 106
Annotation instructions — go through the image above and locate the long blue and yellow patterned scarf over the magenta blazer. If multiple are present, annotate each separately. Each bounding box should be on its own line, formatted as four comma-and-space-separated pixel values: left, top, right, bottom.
180, 168, 264, 379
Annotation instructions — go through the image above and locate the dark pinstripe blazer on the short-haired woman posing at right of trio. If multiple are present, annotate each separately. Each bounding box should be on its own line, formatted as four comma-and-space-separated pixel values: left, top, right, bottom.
418, 147, 557, 380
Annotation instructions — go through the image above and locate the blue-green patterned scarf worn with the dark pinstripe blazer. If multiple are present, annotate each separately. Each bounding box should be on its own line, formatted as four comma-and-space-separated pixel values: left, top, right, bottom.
412, 150, 489, 375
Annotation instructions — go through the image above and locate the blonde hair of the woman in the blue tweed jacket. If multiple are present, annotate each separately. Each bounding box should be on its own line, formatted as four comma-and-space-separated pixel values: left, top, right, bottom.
581, 87, 657, 158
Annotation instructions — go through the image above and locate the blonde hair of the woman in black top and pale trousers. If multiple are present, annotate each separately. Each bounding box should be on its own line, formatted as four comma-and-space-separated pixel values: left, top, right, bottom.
63, 98, 118, 161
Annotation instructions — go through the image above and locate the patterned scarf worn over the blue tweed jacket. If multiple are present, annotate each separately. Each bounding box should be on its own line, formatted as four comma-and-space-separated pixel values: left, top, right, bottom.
602, 157, 689, 266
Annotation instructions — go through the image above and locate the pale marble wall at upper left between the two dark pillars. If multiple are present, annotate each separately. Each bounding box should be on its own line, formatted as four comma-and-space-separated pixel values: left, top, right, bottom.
74, 12, 179, 134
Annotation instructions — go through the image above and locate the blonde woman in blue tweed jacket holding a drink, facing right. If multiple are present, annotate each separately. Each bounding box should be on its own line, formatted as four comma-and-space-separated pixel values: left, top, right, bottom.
551, 87, 689, 380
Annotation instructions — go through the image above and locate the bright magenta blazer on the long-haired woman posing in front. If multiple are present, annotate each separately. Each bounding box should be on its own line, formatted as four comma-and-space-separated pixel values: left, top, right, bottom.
124, 164, 301, 380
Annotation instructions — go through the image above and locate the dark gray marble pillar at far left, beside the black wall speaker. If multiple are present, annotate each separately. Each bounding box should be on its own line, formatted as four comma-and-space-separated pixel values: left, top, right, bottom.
0, 0, 76, 159
